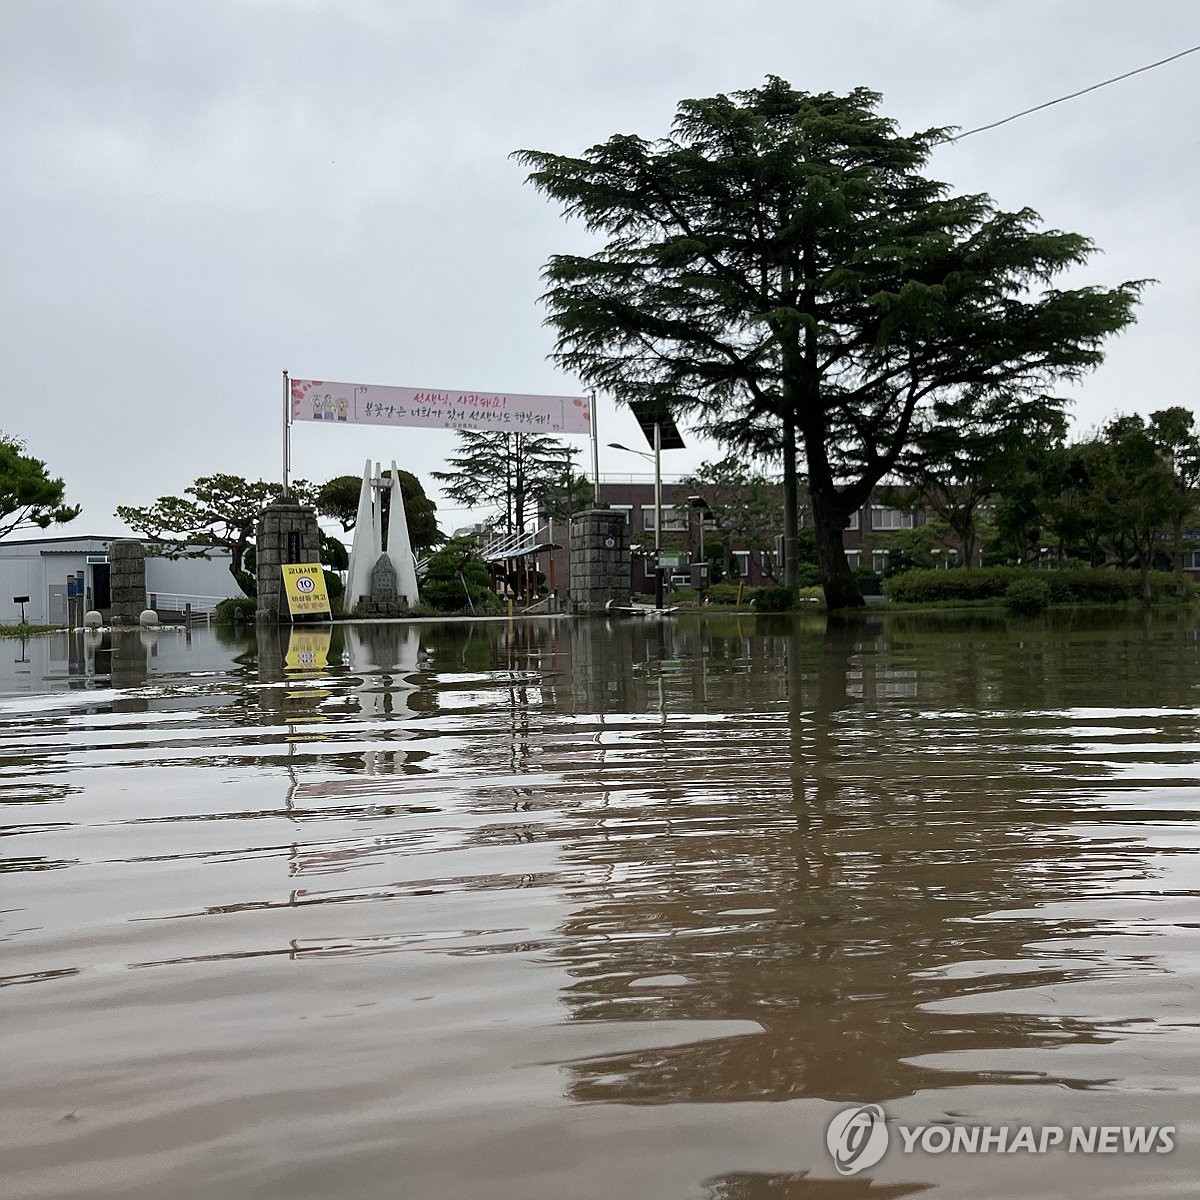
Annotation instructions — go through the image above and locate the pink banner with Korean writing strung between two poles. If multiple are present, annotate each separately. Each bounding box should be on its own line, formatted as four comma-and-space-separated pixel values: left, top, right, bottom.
292, 379, 592, 433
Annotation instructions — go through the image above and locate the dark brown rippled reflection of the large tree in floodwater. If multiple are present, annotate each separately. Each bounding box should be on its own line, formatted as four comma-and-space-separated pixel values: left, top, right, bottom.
549, 618, 1176, 1104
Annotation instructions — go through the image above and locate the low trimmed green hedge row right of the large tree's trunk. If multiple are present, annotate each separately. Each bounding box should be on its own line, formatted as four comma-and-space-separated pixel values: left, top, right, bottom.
883, 566, 1192, 604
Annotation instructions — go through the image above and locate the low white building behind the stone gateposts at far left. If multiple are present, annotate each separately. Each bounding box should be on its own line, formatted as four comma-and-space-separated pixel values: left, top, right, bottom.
0, 536, 241, 625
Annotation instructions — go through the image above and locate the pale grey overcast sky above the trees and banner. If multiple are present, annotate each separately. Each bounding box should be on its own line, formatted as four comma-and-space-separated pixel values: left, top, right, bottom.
0, 0, 1200, 535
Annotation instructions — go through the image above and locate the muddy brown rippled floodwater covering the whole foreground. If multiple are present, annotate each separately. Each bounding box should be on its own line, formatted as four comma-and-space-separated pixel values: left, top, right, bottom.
0, 614, 1200, 1200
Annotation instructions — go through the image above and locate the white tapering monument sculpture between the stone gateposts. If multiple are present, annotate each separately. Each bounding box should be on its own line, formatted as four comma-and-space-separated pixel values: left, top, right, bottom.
346, 458, 419, 617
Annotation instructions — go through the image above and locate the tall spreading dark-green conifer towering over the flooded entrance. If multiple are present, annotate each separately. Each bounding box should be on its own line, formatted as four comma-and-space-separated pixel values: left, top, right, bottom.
516, 77, 1142, 607
